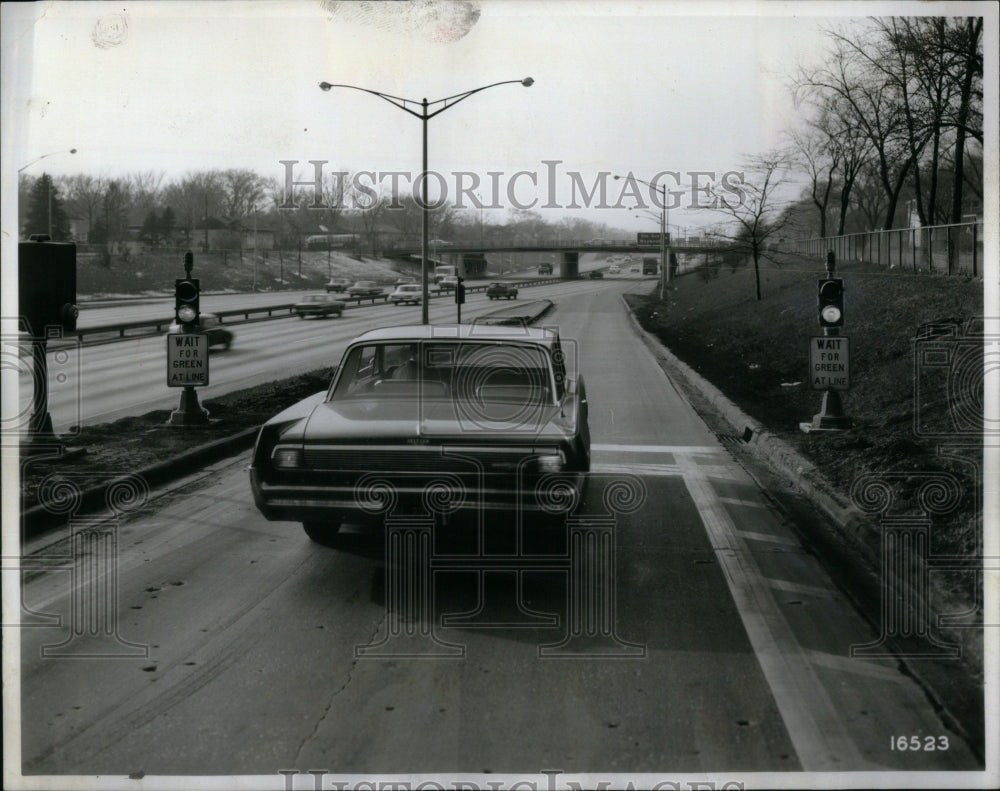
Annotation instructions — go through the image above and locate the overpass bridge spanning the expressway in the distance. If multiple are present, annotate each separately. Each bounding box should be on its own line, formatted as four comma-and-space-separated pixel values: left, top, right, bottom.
383, 239, 732, 278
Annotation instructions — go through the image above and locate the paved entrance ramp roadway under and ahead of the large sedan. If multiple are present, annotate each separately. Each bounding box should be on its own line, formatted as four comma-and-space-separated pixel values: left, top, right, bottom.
13, 281, 976, 782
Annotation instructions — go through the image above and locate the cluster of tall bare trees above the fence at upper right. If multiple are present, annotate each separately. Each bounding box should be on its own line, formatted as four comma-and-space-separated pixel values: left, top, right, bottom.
789, 17, 983, 236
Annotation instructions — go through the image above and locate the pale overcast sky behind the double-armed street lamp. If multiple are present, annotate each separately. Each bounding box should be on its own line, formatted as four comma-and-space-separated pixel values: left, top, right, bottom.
2, 0, 996, 243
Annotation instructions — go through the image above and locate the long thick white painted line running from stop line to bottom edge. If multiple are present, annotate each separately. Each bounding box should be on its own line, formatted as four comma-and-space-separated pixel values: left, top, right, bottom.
677, 455, 881, 772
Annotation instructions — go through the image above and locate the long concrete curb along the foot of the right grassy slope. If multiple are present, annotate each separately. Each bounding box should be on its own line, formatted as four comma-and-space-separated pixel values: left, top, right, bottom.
621, 295, 985, 760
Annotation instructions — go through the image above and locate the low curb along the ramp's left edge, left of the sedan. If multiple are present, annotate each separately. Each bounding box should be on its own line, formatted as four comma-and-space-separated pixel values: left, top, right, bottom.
21, 426, 260, 540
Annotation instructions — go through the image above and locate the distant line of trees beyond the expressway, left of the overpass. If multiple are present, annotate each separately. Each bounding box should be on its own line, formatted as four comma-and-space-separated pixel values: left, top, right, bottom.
19, 169, 627, 255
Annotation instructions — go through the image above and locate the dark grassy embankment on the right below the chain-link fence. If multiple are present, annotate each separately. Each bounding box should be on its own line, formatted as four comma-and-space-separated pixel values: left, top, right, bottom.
631, 251, 983, 597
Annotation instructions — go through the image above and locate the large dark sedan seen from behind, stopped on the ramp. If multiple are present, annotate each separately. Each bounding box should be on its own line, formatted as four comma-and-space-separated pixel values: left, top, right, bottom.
249, 324, 590, 545
